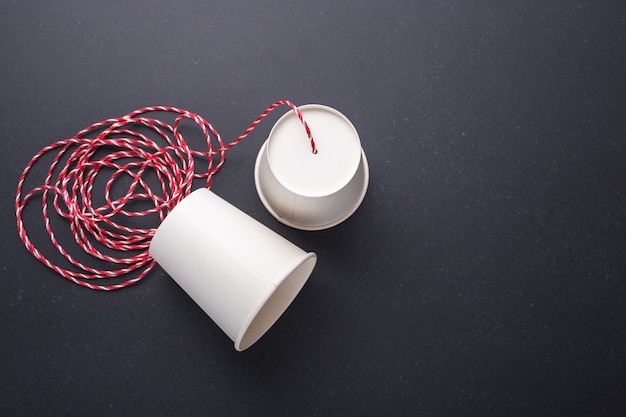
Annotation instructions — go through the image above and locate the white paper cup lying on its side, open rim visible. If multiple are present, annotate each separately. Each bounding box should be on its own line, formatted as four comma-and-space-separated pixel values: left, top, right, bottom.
150, 188, 317, 351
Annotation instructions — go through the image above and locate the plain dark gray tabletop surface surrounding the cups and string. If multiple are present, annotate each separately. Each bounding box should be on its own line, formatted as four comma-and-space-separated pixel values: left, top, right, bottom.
0, 0, 626, 416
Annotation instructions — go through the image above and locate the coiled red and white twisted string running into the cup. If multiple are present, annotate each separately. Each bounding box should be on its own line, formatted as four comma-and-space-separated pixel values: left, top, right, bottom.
15, 100, 317, 291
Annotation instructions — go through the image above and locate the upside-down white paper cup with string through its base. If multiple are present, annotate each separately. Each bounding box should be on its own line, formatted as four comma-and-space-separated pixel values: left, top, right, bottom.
254, 104, 369, 230
